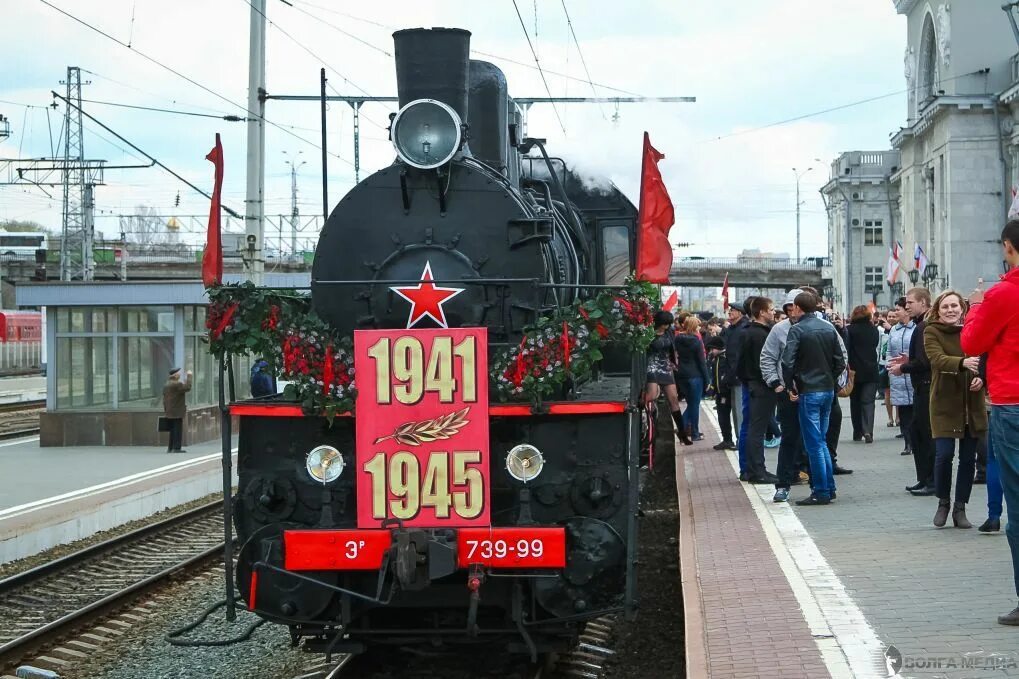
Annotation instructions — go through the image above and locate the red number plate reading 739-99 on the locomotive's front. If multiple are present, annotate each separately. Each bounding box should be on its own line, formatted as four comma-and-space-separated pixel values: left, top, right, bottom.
457, 528, 567, 568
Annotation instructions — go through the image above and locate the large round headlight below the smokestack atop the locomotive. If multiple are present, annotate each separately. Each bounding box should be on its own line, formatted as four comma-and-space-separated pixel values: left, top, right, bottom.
391, 99, 464, 169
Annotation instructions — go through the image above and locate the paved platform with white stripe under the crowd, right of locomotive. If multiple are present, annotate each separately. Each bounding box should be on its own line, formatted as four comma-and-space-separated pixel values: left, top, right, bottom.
677, 400, 1019, 679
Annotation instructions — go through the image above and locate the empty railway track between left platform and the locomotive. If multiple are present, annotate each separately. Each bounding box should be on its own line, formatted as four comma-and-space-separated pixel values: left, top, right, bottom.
0, 503, 223, 670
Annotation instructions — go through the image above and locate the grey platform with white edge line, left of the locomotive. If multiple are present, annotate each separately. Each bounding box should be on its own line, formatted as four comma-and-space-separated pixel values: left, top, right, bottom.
0, 436, 236, 563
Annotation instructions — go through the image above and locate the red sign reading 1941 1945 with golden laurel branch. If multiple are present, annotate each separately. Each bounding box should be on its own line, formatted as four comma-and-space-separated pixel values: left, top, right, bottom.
354, 327, 489, 528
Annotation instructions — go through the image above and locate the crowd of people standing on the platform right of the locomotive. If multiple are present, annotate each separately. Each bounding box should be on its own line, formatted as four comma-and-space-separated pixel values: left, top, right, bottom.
646, 220, 1019, 625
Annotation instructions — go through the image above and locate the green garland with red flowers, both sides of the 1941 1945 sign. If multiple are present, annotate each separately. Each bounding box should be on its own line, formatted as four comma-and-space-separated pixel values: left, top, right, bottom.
206, 279, 657, 420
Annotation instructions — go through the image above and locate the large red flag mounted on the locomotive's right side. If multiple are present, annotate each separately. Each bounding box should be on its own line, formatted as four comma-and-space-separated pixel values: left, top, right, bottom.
637, 133, 676, 283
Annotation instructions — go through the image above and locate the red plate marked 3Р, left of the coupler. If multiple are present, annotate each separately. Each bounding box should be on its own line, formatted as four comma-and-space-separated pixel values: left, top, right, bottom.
283, 530, 392, 571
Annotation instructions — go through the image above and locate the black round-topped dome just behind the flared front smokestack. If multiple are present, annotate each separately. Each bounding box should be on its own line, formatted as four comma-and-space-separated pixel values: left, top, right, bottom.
467, 59, 510, 172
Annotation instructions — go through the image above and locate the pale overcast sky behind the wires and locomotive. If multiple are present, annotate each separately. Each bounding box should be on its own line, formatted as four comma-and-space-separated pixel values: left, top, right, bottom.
0, 0, 906, 256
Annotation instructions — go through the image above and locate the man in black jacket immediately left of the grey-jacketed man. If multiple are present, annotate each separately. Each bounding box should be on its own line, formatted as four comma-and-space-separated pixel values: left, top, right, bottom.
737, 297, 779, 483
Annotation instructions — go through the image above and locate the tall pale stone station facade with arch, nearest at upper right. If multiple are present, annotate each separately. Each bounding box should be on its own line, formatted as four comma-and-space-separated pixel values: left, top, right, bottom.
891, 0, 1016, 292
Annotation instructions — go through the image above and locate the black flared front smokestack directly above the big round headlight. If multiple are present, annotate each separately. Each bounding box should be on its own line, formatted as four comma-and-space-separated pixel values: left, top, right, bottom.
392, 29, 471, 121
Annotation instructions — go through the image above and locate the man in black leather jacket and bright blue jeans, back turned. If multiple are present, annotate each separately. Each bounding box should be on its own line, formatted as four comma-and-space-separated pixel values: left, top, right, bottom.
782, 293, 846, 506
